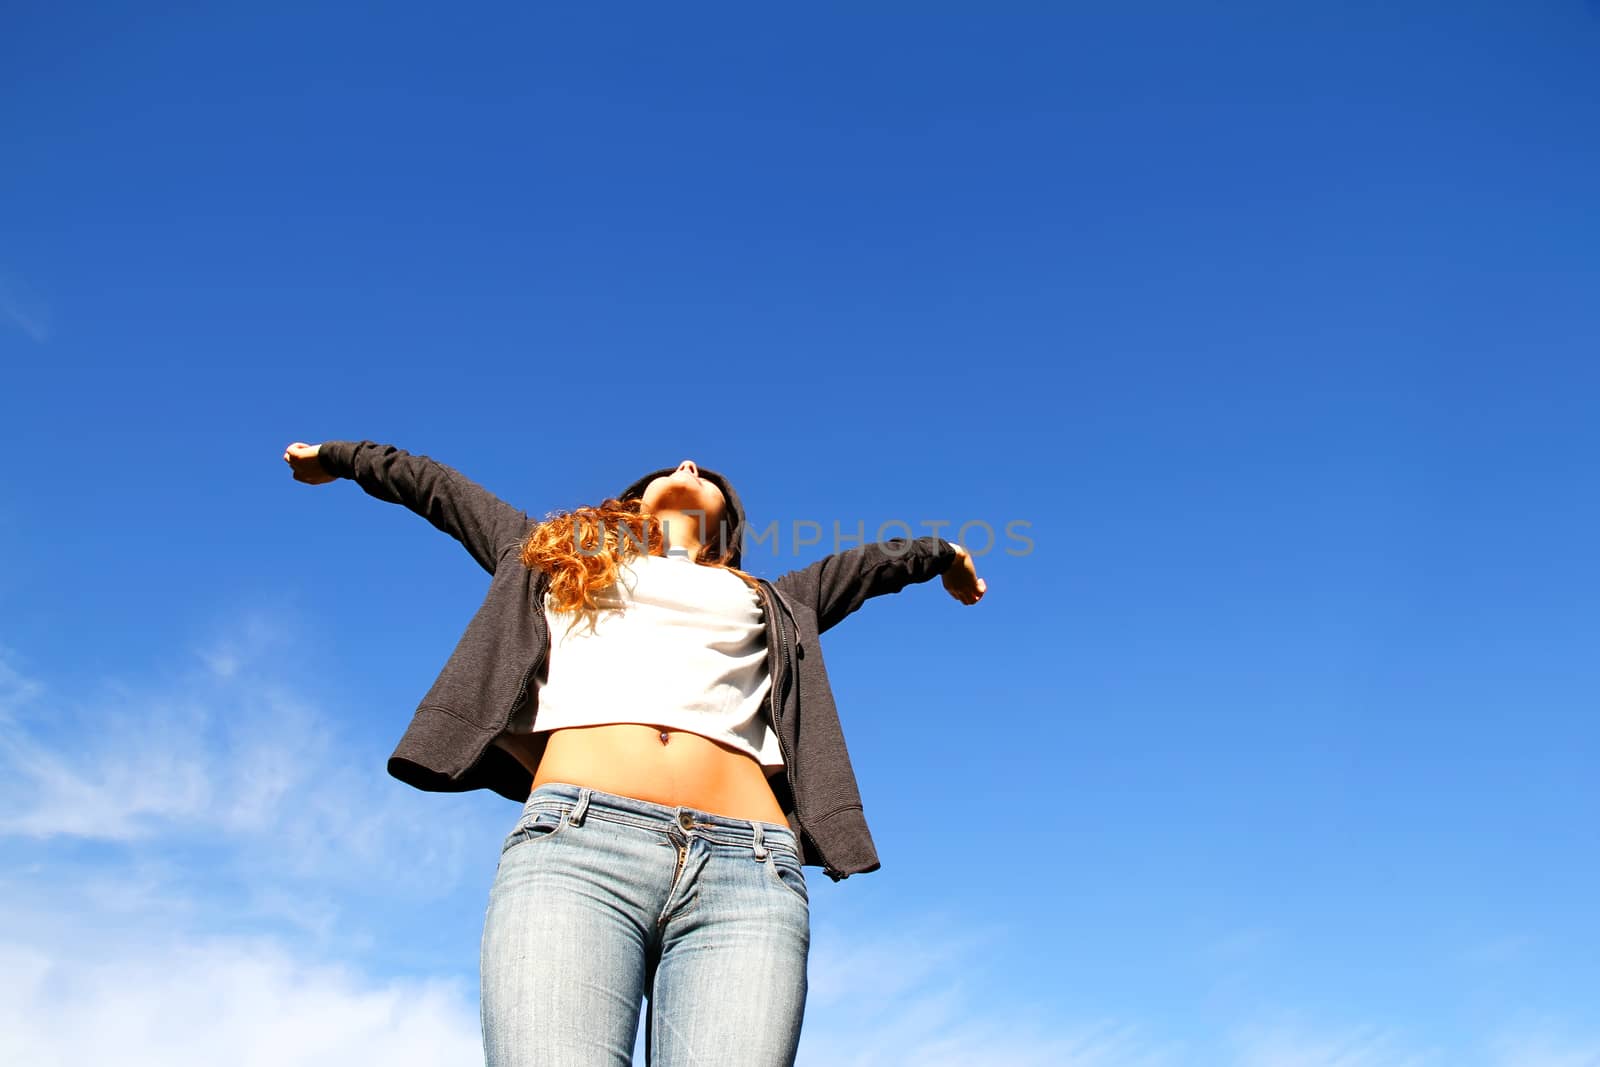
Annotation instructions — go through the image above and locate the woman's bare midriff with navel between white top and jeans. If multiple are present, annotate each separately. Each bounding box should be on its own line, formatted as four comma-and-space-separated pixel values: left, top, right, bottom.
530, 723, 789, 825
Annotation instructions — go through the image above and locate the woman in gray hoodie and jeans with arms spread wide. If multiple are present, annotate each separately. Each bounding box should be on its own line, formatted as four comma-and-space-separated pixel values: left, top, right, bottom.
283, 442, 986, 1067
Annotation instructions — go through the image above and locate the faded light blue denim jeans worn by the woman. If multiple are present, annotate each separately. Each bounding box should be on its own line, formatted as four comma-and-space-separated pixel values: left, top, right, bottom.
480, 782, 811, 1067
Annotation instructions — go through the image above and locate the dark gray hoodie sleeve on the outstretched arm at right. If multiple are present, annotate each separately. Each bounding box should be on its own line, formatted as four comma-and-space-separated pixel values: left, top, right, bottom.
773, 536, 957, 633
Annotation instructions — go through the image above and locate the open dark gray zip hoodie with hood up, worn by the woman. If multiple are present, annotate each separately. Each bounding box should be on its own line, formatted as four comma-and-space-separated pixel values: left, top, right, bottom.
317, 440, 957, 881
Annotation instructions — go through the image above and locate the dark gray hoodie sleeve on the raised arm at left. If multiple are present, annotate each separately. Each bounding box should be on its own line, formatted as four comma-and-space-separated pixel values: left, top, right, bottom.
317, 442, 533, 574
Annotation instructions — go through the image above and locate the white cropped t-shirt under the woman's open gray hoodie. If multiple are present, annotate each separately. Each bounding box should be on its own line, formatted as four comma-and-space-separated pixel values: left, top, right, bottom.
501, 549, 784, 773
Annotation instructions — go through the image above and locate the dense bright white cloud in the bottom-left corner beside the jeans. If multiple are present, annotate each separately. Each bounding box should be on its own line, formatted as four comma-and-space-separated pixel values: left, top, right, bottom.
0, 937, 483, 1067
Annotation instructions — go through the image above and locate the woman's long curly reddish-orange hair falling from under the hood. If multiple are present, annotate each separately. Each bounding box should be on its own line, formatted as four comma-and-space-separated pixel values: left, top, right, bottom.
522, 496, 757, 630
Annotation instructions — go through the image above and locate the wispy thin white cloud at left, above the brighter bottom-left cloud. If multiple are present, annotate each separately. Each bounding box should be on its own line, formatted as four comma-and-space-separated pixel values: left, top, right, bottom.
0, 639, 496, 897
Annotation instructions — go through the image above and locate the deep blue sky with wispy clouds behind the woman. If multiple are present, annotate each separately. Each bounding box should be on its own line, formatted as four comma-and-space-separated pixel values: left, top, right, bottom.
0, 0, 1600, 1067
